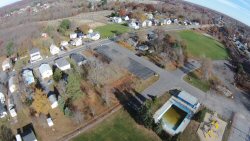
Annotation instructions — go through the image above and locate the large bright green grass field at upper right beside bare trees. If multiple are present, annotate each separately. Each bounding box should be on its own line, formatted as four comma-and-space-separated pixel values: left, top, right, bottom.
178, 31, 228, 60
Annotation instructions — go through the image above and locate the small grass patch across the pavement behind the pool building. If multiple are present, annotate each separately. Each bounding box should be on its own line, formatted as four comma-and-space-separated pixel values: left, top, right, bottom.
184, 71, 210, 92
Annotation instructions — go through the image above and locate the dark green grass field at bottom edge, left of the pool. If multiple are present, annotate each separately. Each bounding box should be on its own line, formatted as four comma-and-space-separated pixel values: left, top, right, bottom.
73, 110, 160, 141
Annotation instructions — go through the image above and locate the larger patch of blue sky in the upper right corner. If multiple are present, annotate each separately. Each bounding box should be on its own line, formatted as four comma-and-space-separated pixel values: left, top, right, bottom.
185, 0, 250, 26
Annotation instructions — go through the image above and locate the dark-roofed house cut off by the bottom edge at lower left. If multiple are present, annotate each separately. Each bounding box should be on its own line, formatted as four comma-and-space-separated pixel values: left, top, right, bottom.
18, 125, 37, 141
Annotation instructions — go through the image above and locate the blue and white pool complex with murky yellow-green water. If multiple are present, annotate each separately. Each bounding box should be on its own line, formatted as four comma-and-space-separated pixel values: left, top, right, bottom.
153, 90, 200, 135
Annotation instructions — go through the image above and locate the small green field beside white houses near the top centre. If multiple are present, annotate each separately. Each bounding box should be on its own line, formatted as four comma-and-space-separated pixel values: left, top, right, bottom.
95, 24, 128, 38
